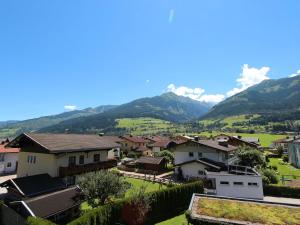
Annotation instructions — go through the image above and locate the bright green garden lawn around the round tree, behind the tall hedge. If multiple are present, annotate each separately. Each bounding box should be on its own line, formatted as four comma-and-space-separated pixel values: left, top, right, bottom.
81, 178, 166, 211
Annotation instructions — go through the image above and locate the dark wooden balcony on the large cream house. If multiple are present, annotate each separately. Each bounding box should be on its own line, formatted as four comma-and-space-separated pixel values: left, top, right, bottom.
59, 159, 117, 177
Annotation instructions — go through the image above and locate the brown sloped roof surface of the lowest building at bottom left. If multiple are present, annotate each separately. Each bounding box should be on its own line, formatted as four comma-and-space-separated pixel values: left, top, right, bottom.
24, 187, 81, 218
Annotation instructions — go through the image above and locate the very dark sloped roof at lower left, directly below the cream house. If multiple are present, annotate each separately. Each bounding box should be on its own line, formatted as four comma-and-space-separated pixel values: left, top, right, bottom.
0, 174, 66, 197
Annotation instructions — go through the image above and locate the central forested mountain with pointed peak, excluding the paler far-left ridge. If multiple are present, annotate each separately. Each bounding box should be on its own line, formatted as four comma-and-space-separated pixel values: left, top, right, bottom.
39, 93, 210, 133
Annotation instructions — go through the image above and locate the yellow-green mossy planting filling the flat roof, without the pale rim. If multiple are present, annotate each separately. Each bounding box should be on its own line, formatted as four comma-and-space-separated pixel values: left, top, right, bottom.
197, 198, 300, 225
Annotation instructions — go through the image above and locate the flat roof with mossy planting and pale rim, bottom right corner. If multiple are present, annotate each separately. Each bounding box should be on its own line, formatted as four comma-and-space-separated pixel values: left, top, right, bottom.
189, 194, 300, 225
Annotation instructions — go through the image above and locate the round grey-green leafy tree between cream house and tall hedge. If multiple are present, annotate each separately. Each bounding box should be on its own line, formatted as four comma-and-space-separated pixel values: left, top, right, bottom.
78, 170, 131, 207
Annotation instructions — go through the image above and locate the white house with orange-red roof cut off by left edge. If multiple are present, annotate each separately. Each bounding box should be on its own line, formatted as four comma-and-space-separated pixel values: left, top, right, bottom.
0, 142, 20, 175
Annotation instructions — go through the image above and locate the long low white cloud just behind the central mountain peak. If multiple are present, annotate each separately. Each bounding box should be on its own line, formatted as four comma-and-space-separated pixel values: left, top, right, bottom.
167, 84, 225, 104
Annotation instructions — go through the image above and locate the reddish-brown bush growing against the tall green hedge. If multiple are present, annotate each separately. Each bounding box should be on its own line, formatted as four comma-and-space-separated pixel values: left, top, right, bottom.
122, 185, 152, 225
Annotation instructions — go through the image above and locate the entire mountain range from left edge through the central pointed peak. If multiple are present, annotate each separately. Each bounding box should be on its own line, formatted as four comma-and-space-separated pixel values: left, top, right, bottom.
0, 93, 211, 136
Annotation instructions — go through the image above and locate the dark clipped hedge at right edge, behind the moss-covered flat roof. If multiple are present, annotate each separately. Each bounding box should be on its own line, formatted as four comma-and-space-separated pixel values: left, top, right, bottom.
264, 184, 300, 198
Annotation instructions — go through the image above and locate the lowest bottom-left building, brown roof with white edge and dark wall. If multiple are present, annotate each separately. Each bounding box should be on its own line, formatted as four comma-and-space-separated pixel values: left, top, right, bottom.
9, 186, 82, 224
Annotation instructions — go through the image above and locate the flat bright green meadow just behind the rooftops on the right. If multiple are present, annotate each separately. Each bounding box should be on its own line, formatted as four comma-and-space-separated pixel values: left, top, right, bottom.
199, 131, 286, 147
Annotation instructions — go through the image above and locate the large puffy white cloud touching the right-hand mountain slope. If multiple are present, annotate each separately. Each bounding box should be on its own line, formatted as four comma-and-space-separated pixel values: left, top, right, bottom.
226, 64, 270, 97
